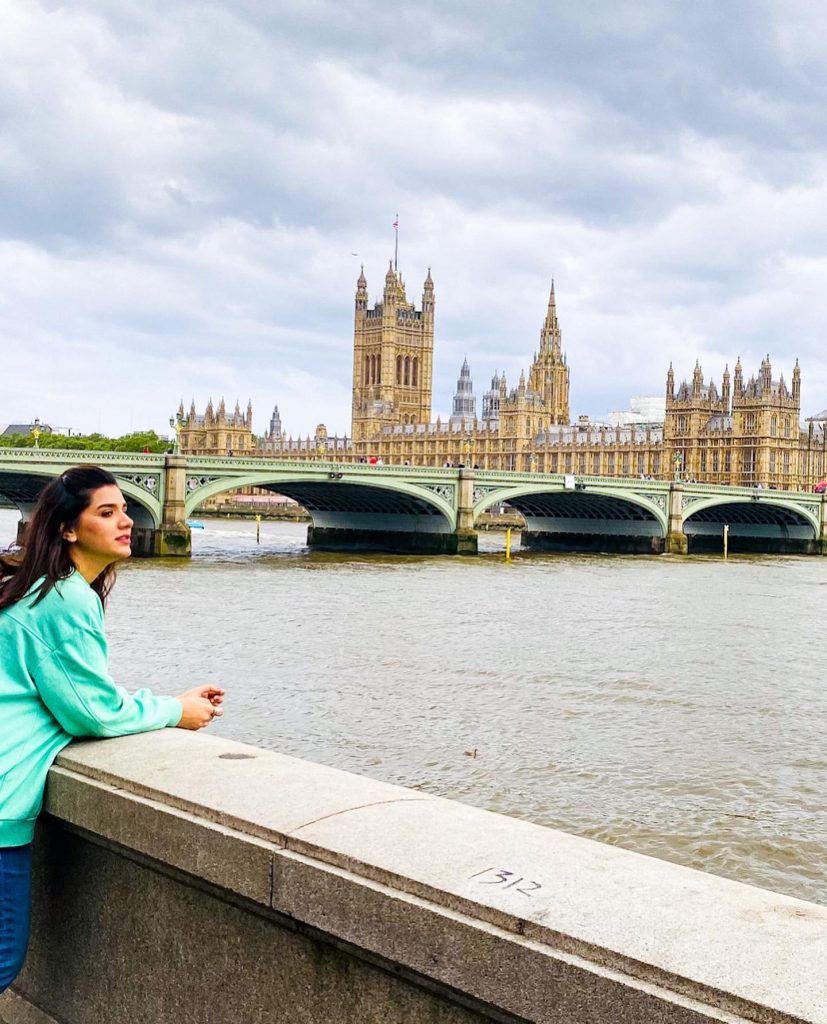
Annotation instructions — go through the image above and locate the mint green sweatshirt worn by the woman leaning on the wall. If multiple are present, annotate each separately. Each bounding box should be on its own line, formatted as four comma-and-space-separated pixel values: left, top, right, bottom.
0, 572, 182, 847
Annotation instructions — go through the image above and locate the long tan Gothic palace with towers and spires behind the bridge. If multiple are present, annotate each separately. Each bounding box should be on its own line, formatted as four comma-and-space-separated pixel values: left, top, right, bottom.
178, 263, 827, 489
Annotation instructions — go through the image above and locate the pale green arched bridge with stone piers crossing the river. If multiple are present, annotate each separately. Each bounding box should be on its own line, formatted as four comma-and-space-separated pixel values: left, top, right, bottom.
0, 449, 827, 556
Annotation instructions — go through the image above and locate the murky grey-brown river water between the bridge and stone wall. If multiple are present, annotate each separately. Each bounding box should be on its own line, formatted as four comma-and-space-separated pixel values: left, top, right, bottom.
0, 511, 827, 903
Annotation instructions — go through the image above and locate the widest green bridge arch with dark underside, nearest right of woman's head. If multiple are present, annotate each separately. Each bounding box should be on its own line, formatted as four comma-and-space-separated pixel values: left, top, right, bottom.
185, 463, 456, 534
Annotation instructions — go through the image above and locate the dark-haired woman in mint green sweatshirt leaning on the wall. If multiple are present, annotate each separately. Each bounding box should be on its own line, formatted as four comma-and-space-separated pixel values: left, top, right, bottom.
0, 466, 224, 992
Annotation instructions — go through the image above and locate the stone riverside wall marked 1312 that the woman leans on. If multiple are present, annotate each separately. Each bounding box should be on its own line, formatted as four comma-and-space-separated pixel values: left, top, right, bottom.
0, 730, 827, 1024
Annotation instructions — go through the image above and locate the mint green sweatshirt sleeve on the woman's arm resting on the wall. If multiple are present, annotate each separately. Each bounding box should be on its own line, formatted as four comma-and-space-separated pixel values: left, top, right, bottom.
33, 622, 183, 736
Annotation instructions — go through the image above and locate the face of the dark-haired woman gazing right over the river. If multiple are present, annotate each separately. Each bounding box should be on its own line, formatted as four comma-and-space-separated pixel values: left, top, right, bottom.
63, 483, 132, 583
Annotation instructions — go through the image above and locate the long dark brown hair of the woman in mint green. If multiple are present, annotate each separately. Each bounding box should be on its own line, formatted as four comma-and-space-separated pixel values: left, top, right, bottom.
0, 466, 118, 611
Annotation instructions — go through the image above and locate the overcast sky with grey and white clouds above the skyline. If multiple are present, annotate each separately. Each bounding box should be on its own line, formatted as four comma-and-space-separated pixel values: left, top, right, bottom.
0, 0, 827, 433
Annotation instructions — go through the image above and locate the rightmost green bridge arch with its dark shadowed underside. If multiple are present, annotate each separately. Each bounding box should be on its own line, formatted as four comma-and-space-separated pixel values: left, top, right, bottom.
683, 493, 820, 554
